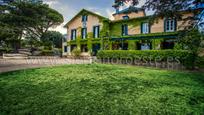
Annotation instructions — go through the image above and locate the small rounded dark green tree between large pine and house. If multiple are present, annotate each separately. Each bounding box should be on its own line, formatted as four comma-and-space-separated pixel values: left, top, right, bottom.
41, 31, 64, 48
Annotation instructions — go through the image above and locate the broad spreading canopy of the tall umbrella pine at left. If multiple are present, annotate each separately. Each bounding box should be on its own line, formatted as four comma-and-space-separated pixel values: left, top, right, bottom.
7, 2, 63, 38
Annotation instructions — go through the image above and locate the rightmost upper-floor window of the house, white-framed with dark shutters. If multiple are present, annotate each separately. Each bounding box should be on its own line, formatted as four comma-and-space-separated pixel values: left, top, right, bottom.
164, 19, 176, 32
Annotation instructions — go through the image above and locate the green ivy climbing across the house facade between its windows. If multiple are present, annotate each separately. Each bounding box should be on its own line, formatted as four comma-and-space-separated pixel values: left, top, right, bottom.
65, 11, 177, 53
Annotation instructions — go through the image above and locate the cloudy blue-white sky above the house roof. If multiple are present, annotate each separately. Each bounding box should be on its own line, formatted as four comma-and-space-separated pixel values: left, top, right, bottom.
44, 0, 148, 34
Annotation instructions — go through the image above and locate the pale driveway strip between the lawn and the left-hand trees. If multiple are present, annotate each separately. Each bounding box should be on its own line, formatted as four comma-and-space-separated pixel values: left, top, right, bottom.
0, 58, 92, 73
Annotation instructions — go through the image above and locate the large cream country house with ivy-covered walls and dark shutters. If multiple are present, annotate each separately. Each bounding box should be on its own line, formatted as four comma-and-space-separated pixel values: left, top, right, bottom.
63, 6, 193, 55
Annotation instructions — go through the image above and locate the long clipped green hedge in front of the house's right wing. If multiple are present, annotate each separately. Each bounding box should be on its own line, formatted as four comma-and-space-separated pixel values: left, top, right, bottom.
97, 50, 195, 67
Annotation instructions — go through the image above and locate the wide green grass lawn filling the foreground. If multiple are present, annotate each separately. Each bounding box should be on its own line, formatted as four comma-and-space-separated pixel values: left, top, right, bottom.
0, 64, 204, 115
